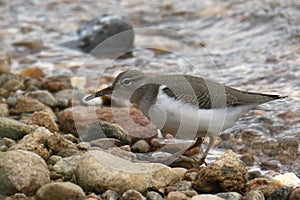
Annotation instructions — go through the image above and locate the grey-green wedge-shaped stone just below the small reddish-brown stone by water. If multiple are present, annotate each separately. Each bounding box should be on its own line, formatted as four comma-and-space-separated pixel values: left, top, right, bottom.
27, 90, 57, 107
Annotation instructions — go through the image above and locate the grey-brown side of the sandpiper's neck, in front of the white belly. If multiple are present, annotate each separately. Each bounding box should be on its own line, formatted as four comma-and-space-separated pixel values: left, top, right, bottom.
130, 84, 159, 117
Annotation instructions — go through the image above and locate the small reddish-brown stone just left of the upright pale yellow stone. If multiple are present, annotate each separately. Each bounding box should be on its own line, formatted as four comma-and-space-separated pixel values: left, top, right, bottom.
43, 76, 72, 92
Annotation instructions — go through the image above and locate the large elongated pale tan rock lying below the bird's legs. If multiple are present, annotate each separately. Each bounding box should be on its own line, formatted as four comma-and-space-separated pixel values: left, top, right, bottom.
75, 150, 179, 194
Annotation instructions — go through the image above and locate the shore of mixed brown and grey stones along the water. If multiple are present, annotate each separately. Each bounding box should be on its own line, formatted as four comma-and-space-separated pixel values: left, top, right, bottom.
0, 66, 300, 200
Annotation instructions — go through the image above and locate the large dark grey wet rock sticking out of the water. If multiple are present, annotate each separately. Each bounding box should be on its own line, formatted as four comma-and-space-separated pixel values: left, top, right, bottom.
77, 14, 134, 53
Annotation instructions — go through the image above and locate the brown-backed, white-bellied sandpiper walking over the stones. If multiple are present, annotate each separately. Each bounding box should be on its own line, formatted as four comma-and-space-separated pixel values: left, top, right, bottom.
85, 70, 285, 164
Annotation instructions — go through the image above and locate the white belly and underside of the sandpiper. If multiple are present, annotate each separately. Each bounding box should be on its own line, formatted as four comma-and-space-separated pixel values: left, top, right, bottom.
149, 90, 255, 139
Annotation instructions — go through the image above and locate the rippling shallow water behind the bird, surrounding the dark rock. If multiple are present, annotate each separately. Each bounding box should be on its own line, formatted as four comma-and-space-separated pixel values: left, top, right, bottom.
0, 0, 300, 171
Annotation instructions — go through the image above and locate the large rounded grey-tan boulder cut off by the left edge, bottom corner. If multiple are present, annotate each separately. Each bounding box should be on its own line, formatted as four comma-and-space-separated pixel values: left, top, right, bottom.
0, 150, 50, 195
